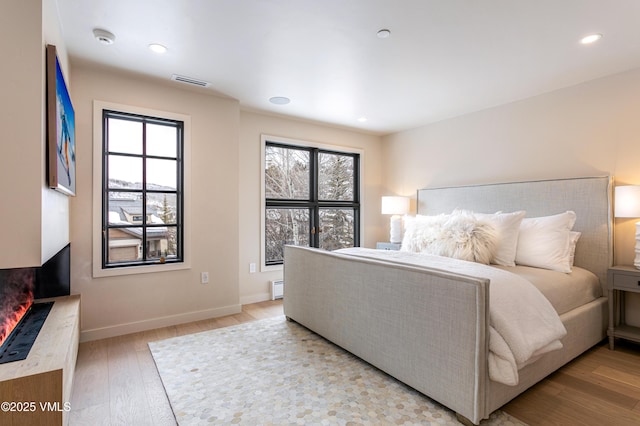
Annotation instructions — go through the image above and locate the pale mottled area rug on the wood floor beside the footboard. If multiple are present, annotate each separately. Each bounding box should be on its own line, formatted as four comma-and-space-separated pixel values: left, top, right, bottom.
149, 316, 524, 426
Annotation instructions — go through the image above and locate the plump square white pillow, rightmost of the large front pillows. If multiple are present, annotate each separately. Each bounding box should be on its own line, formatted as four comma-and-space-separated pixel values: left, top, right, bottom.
516, 211, 576, 273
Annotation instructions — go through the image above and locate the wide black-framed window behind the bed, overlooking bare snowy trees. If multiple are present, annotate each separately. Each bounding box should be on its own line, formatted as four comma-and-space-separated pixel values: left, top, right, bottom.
264, 140, 360, 266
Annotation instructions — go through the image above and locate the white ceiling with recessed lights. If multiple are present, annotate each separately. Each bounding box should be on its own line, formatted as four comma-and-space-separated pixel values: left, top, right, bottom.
56, 0, 640, 134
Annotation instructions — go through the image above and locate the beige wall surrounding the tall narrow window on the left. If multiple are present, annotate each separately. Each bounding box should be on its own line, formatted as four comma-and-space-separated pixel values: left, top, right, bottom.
71, 62, 240, 340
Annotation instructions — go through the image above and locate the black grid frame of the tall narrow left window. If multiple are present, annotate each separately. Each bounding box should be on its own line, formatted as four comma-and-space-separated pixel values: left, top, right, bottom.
101, 109, 185, 269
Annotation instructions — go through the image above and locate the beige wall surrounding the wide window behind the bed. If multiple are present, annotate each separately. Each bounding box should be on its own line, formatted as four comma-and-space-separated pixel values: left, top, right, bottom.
239, 111, 385, 304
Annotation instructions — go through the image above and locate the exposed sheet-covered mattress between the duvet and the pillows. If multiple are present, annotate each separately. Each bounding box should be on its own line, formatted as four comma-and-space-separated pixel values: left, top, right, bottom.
492, 265, 602, 315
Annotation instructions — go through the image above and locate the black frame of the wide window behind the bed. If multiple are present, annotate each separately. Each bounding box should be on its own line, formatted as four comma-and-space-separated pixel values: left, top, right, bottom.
263, 139, 361, 266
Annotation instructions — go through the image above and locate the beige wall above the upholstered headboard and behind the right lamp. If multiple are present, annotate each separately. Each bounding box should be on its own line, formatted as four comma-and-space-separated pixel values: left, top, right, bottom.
383, 69, 640, 264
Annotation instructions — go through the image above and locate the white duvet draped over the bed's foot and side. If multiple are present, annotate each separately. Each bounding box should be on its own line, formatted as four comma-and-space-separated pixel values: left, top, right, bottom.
337, 247, 567, 385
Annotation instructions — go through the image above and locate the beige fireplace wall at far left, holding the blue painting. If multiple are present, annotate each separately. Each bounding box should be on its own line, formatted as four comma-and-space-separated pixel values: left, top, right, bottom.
0, 0, 69, 268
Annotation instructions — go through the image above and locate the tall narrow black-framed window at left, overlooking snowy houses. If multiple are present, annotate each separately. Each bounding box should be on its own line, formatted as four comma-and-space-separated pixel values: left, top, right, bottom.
101, 109, 184, 268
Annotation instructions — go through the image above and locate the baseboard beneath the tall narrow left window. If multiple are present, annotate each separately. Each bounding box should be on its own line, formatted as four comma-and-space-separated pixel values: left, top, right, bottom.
80, 305, 242, 342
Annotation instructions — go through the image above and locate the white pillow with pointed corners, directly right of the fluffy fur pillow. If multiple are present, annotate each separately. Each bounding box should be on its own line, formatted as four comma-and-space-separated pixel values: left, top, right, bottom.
474, 210, 526, 266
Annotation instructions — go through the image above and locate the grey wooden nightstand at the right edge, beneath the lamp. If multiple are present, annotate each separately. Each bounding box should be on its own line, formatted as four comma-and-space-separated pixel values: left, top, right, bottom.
607, 266, 640, 350
